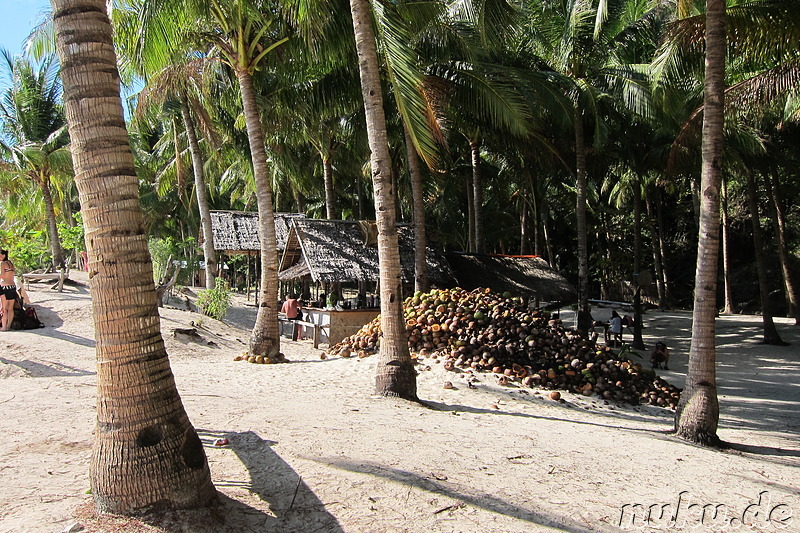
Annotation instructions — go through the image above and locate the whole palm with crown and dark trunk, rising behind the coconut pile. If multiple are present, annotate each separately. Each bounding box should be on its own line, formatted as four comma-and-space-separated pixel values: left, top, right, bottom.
526, 0, 664, 331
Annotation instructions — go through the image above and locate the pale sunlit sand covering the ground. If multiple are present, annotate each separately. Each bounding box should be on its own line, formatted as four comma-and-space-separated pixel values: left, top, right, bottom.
0, 272, 800, 533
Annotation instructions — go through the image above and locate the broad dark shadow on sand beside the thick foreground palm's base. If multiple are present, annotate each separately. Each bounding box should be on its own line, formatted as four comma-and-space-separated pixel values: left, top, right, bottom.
198, 430, 344, 533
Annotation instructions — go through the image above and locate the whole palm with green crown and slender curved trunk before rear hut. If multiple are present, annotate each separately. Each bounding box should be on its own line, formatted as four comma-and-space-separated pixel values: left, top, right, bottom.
130, 0, 288, 361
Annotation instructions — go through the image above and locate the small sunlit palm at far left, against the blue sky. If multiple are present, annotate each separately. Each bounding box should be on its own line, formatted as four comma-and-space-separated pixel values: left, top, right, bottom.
0, 50, 71, 268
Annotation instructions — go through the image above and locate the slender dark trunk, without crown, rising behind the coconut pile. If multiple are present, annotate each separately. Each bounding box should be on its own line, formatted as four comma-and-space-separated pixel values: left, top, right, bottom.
575, 107, 592, 333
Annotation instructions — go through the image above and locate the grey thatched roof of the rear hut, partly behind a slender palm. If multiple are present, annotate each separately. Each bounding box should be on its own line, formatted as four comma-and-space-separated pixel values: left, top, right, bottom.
211, 211, 305, 254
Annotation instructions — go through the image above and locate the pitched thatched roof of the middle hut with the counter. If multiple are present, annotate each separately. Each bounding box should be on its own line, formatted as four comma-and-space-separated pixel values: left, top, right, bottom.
278, 218, 454, 286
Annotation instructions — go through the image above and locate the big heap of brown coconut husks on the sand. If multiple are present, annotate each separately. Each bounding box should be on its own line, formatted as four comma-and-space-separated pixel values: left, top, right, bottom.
328, 288, 680, 409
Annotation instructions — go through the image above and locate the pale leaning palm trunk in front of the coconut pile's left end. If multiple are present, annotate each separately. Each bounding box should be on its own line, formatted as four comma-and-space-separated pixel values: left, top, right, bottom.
350, 0, 417, 400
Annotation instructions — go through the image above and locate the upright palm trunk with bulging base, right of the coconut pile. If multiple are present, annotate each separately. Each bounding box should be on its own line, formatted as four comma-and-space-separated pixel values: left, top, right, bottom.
675, 0, 725, 445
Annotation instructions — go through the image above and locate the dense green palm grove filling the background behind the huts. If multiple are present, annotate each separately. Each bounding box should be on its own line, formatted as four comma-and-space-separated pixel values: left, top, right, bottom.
0, 1, 798, 313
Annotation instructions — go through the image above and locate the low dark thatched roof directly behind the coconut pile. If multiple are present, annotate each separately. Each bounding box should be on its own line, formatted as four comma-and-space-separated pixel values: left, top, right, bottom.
447, 254, 577, 302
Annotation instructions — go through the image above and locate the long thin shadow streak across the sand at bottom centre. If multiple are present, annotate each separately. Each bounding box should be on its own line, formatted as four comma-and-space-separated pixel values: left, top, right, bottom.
310, 457, 596, 533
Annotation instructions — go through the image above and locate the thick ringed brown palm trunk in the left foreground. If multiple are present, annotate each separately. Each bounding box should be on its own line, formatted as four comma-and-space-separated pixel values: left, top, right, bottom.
51, 0, 216, 514
